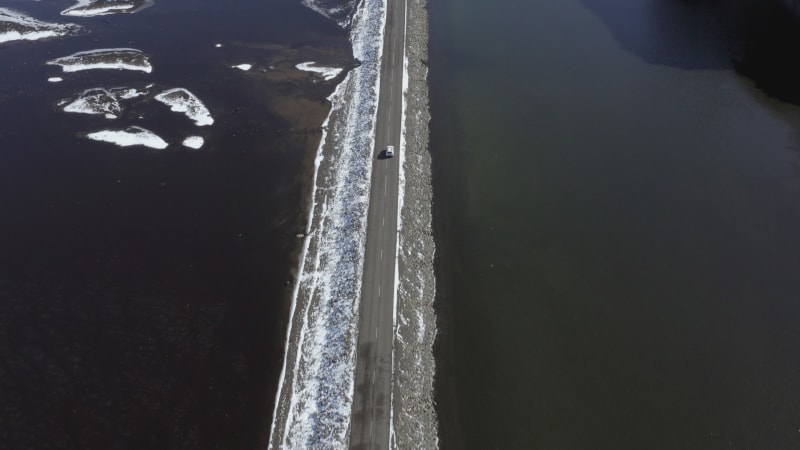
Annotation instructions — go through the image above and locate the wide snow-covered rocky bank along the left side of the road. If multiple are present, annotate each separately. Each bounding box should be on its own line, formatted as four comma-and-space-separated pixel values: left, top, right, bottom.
269, 0, 386, 450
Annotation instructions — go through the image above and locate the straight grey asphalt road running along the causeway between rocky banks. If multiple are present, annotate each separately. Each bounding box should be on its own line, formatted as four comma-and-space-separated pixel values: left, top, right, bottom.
350, 0, 406, 450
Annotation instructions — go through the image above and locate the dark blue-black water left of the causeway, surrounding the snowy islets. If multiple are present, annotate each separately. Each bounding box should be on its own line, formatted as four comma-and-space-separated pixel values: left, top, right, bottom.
0, 0, 350, 450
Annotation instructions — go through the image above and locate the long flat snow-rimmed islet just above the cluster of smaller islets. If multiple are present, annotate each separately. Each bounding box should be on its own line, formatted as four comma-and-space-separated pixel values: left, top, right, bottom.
47, 48, 153, 73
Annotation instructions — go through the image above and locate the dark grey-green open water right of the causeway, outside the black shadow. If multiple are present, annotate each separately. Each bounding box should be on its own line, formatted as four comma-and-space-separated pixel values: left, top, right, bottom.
430, 0, 800, 449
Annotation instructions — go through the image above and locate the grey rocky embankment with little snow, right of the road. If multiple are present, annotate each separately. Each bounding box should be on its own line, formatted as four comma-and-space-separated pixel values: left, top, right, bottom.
391, 0, 438, 449
